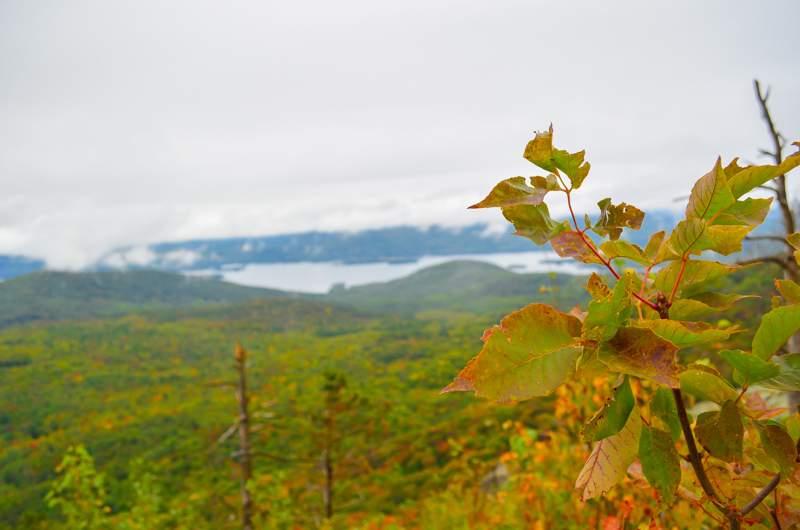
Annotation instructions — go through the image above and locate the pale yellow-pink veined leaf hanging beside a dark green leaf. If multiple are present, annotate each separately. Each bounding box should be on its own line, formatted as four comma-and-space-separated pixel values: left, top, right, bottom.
575, 412, 642, 501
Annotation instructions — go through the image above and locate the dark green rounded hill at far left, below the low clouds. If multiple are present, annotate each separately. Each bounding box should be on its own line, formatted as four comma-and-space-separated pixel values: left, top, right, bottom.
0, 270, 296, 328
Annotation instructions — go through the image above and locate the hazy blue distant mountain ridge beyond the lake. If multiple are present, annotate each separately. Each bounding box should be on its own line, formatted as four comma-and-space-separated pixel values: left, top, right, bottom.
92, 211, 678, 271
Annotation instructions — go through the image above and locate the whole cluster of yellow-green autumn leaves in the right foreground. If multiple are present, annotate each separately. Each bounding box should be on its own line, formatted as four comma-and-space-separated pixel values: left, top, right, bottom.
442, 127, 800, 527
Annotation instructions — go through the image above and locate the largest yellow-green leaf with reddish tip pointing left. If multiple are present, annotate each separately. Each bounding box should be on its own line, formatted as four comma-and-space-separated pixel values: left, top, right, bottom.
442, 304, 581, 403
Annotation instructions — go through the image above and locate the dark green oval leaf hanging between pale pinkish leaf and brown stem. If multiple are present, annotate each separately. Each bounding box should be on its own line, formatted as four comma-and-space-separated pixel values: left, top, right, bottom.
639, 425, 681, 509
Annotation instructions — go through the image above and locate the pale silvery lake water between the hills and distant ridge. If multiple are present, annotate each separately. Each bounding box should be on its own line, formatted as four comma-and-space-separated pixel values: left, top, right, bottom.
188, 251, 592, 294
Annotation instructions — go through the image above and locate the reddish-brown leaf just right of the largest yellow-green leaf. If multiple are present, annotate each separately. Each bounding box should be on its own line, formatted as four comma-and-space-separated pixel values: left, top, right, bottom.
598, 326, 680, 388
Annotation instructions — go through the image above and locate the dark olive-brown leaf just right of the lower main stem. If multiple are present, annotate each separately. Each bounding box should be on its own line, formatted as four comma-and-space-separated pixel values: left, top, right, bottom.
694, 399, 744, 462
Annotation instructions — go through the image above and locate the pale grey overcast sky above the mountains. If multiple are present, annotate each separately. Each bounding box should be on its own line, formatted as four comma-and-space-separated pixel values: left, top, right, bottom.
0, 0, 800, 268
